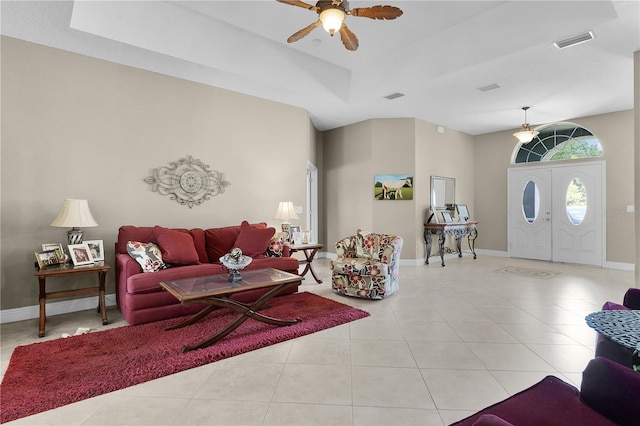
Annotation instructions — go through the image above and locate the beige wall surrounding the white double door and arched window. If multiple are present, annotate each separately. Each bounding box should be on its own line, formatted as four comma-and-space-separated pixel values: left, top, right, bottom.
472, 110, 635, 264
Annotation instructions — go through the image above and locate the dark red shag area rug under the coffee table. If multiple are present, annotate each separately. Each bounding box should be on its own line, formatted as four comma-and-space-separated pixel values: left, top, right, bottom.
0, 292, 369, 423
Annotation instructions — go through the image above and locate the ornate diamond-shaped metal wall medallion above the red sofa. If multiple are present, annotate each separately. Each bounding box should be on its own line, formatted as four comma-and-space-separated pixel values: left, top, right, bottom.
144, 155, 231, 208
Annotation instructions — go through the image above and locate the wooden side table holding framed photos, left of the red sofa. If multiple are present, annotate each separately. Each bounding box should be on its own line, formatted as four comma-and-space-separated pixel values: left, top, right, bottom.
33, 262, 111, 337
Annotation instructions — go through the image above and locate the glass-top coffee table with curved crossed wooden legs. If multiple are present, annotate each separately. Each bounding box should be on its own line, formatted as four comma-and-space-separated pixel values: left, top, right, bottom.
160, 268, 302, 352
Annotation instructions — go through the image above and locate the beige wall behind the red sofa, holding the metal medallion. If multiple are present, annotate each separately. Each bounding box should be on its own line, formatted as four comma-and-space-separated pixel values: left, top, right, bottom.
0, 37, 316, 309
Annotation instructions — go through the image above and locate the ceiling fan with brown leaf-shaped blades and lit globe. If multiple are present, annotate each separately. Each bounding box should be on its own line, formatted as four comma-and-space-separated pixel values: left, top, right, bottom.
278, 0, 402, 50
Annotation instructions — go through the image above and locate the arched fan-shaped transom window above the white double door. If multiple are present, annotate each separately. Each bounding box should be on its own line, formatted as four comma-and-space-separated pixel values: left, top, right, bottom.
514, 123, 602, 164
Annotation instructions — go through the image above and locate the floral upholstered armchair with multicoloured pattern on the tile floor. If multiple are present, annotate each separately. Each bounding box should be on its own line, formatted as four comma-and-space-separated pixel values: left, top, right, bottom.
331, 230, 403, 299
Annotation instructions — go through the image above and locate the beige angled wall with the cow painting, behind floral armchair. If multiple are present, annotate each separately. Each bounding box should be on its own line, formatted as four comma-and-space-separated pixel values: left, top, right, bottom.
323, 119, 474, 260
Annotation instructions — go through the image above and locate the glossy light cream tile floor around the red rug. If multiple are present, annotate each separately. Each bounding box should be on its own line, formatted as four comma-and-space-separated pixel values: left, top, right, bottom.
0, 255, 634, 425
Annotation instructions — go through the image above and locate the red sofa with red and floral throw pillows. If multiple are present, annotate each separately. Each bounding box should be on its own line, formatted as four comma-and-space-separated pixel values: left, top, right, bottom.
115, 221, 299, 325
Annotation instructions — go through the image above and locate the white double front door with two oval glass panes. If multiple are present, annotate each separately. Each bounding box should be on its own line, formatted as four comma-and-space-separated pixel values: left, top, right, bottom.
508, 162, 605, 266
